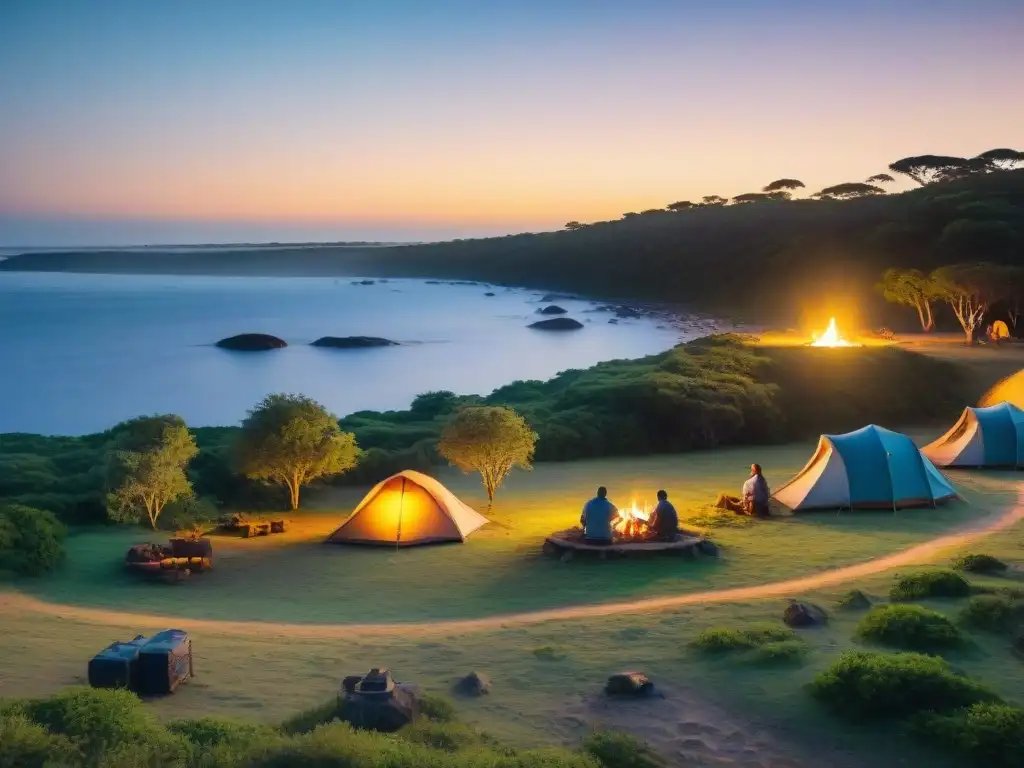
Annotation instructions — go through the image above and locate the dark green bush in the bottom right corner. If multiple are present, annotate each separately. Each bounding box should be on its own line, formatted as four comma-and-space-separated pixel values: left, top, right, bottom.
913, 702, 1024, 768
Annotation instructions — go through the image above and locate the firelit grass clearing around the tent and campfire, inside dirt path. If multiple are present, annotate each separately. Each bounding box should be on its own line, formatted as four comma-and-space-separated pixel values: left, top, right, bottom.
8, 443, 1013, 624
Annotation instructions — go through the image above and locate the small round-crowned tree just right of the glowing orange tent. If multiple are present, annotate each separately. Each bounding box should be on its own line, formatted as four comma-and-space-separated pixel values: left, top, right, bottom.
437, 406, 537, 502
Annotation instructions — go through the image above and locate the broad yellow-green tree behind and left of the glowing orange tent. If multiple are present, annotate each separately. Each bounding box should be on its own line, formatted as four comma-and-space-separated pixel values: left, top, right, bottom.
237, 394, 359, 510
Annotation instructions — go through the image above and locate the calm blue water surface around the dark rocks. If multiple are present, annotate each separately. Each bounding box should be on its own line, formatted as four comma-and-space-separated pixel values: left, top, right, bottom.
0, 272, 710, 434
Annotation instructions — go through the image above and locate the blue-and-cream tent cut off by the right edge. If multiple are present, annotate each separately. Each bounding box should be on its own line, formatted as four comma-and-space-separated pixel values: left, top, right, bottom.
922, 402, 1024, 468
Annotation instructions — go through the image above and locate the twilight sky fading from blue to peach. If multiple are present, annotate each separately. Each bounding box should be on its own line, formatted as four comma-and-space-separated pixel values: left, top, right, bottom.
0, 0, 1024, 246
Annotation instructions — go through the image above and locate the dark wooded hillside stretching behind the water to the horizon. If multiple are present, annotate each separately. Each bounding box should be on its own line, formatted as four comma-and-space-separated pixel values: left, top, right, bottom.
0, 169, 1024, 317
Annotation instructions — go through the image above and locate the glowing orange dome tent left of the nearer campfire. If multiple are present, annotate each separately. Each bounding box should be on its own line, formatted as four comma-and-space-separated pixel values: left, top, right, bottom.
327, 469, 487, 547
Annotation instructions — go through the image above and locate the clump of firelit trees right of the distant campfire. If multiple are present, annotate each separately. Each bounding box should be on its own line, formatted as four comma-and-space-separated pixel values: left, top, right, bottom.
878, 262, 1024, 344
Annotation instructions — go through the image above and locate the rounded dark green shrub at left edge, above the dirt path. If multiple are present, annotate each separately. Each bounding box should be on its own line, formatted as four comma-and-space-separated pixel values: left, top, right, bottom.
0, 504, 66, 575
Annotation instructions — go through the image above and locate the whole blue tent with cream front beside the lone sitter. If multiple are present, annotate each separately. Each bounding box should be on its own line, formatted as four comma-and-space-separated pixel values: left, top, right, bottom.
772, 424, 956, 510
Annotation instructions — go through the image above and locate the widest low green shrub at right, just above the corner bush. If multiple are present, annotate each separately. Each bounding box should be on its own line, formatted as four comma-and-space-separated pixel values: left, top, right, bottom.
810, 651, 997, 719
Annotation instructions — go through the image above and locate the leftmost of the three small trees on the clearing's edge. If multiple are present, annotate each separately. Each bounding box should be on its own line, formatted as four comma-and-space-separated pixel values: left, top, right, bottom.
108, 416, 199, 530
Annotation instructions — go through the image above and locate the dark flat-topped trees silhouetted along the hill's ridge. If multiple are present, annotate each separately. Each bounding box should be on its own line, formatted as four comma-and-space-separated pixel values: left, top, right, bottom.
565, 147, 1024, 229
